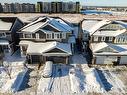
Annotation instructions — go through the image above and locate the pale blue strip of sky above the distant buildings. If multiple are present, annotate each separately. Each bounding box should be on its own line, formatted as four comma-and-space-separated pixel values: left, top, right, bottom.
0, 0, 127, 6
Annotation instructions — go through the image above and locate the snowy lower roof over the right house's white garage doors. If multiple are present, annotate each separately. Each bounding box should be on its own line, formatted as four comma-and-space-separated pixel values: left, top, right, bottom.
91, 42, 127, 55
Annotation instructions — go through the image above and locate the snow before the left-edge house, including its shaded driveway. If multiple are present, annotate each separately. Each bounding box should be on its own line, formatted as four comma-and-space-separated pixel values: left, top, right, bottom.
0, 51, 27, 93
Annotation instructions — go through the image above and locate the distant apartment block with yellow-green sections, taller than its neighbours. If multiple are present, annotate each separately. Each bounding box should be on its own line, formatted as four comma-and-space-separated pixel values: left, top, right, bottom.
37, 2, 80, 13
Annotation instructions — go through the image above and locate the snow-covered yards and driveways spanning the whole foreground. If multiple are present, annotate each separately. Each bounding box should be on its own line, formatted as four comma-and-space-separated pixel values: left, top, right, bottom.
0, 54, 127, 95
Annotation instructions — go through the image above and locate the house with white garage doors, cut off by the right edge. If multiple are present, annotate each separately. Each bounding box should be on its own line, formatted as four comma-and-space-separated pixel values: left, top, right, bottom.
82, 19, 127, 65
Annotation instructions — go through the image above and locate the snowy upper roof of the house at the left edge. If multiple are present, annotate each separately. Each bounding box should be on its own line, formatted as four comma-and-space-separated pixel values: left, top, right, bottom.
0, 19, 13, 30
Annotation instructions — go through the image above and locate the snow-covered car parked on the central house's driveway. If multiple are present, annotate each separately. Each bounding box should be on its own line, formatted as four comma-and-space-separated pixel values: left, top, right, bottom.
42, 61, 53, 78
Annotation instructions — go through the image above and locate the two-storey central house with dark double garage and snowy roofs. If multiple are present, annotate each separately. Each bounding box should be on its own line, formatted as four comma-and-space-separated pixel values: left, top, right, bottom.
19, 16, 75, 64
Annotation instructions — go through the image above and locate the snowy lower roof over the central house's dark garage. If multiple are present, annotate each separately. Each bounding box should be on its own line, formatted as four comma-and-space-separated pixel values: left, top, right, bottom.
27, 41, 72, 55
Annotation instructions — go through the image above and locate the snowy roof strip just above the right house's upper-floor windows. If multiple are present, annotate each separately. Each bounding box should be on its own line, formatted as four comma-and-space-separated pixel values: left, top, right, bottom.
93, 29, 126, 37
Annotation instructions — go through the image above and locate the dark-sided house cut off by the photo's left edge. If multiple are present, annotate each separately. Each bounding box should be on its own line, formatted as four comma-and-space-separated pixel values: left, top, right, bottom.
0, 17, 23, 57
